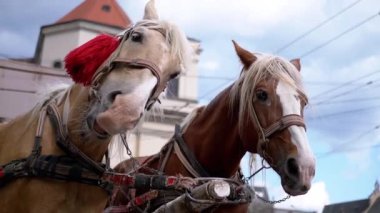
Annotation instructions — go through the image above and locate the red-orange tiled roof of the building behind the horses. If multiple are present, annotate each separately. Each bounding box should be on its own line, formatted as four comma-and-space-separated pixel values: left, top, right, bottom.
56, 0, 131, 28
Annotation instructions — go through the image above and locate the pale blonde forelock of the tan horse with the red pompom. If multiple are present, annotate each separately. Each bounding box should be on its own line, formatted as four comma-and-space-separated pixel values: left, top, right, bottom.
134, 20, 192, 70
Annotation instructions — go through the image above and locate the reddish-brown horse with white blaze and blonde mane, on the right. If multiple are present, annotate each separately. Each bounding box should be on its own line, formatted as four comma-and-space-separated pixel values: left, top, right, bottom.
112, 42, 315, 212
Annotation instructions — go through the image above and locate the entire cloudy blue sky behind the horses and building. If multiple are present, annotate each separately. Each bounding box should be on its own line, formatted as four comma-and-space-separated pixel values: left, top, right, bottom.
0, 0, 380, 210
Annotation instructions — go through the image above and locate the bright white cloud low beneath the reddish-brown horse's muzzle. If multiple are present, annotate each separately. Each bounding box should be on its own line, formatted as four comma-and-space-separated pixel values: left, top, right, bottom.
276, 182, 330, 212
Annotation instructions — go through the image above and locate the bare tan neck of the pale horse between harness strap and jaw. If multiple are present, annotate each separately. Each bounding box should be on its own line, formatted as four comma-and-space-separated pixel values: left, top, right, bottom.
63, 84, 111, 161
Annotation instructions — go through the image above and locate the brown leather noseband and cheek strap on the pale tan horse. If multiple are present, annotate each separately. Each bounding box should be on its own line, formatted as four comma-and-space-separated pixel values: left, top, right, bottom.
91, 27, 168, 110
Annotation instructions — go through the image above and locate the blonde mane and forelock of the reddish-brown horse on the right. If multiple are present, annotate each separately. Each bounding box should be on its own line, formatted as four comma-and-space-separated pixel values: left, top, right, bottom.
230, 54, 307, 128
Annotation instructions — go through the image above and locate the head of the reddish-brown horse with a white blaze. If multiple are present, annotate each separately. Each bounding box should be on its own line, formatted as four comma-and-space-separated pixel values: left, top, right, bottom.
231, 42, 315, 195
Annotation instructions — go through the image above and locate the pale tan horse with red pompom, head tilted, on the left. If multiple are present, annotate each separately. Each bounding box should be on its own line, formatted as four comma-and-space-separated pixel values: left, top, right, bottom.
0, 2, 190, 212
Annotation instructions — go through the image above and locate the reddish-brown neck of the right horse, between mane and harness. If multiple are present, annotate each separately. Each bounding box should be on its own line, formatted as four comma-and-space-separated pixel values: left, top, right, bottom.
183, 87, 245, 177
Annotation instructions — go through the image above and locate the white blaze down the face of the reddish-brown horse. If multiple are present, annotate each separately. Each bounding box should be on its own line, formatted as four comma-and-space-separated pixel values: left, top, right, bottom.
276, 81, 314, 164
